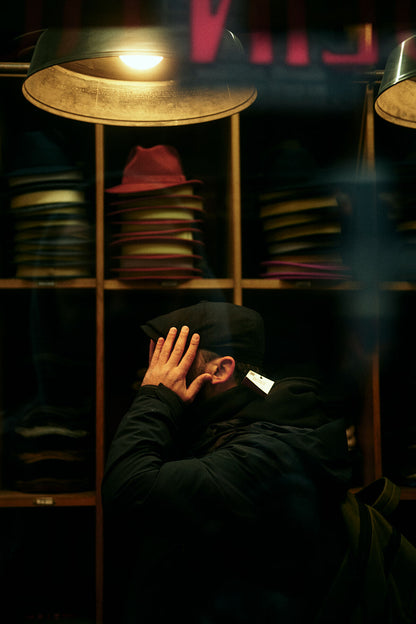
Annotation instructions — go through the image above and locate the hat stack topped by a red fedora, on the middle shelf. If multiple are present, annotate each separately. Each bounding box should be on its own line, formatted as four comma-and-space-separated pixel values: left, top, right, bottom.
106, 145, 204, 281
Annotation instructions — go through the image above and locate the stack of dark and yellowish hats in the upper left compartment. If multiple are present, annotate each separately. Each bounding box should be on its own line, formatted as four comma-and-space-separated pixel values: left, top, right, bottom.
7, 130, 93, 279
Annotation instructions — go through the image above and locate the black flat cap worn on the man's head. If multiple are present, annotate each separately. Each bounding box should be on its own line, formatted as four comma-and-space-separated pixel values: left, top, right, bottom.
141, 301, 264, 366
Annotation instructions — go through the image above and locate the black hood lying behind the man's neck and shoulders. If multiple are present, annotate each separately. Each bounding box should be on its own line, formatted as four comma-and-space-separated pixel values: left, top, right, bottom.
193, 377, 352, 487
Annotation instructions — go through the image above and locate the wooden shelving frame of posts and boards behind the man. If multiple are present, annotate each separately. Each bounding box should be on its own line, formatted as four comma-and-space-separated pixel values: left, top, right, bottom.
0, 63, 416, 624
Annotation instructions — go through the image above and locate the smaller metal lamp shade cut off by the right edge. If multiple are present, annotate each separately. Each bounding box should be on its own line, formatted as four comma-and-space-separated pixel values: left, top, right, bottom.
375, 35, 416, 128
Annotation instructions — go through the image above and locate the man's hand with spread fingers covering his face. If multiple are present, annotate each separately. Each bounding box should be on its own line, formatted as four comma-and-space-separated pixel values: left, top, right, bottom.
142, 325, 211, 403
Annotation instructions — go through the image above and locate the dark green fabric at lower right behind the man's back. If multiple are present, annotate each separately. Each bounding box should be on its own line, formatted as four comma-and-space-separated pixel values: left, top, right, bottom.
314, 478, 416, 624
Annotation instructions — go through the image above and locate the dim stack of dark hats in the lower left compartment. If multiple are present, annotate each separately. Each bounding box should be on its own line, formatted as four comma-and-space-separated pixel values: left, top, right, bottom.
2, 289, 95, 492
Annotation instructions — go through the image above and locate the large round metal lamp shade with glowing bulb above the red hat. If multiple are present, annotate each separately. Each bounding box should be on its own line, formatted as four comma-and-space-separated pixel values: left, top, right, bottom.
23, 27, 257, 126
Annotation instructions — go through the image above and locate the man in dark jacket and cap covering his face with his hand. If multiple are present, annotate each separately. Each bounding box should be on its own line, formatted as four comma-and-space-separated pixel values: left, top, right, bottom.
102, 302, 350, 624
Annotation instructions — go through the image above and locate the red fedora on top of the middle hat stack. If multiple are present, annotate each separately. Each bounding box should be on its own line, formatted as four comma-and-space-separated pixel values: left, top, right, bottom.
106, 145, 201, 193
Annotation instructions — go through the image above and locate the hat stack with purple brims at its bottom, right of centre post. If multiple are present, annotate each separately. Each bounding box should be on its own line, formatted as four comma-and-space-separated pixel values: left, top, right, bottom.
258, 139, 349, 280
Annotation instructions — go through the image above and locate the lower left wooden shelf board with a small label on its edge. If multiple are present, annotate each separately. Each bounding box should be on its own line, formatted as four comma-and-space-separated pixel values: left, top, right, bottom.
0, 490, 97, 507
